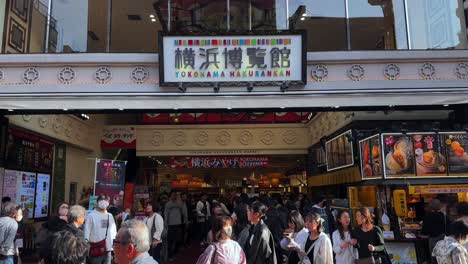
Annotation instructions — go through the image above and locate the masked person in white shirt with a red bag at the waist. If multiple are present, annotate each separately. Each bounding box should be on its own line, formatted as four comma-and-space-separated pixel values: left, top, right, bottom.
84, 194, 117, 264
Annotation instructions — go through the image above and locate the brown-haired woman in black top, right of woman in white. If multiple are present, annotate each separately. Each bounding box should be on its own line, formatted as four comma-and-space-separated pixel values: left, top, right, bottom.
351, 207, 387, 263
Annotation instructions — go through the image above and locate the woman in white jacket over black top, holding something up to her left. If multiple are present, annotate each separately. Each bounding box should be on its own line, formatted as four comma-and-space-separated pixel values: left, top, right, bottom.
291, 213, 333, 264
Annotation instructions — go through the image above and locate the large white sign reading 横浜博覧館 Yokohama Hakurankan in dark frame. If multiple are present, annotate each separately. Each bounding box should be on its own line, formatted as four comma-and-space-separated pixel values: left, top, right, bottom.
159, 33, 306, 86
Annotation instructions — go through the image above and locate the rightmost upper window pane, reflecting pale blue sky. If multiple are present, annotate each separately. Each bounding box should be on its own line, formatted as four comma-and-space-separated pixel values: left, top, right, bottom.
407, 0, 467, 49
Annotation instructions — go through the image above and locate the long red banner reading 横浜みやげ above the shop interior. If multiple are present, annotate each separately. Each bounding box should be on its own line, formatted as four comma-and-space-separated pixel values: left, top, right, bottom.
170, 156, 269, 169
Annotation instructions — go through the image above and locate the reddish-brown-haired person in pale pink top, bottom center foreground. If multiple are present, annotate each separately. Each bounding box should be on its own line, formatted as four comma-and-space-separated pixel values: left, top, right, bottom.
197, 216, 247, 264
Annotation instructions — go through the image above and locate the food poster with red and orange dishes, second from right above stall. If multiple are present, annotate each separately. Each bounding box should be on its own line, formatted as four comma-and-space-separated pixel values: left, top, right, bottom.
411, 133, 447, 176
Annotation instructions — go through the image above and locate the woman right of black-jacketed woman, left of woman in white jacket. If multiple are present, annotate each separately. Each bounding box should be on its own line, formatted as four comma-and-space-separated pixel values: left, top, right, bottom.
280, 210, 309, 264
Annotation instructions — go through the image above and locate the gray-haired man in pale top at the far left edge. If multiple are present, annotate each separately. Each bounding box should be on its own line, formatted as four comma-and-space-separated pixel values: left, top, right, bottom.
0, 202, 18, 264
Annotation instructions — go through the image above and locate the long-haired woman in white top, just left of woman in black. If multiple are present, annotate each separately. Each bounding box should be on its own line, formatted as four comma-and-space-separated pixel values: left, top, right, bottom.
332, 210, 357, 264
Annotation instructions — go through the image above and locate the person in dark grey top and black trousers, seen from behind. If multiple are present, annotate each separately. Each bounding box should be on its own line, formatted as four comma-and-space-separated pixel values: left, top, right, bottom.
164, 191, 188, 261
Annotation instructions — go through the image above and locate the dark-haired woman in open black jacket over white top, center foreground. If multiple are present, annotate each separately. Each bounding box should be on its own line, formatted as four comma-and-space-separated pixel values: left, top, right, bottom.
244, 202, 277, 264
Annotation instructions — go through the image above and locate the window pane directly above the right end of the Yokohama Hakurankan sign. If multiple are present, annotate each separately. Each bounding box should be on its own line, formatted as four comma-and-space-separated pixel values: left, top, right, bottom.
288, 0, 348, 51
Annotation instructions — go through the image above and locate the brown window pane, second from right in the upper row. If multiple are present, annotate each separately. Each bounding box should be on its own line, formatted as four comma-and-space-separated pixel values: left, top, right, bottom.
348, 0, 395, 50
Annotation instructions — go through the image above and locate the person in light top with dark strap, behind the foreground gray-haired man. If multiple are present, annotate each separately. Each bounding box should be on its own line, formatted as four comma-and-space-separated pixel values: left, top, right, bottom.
143, 202, 164, 262
